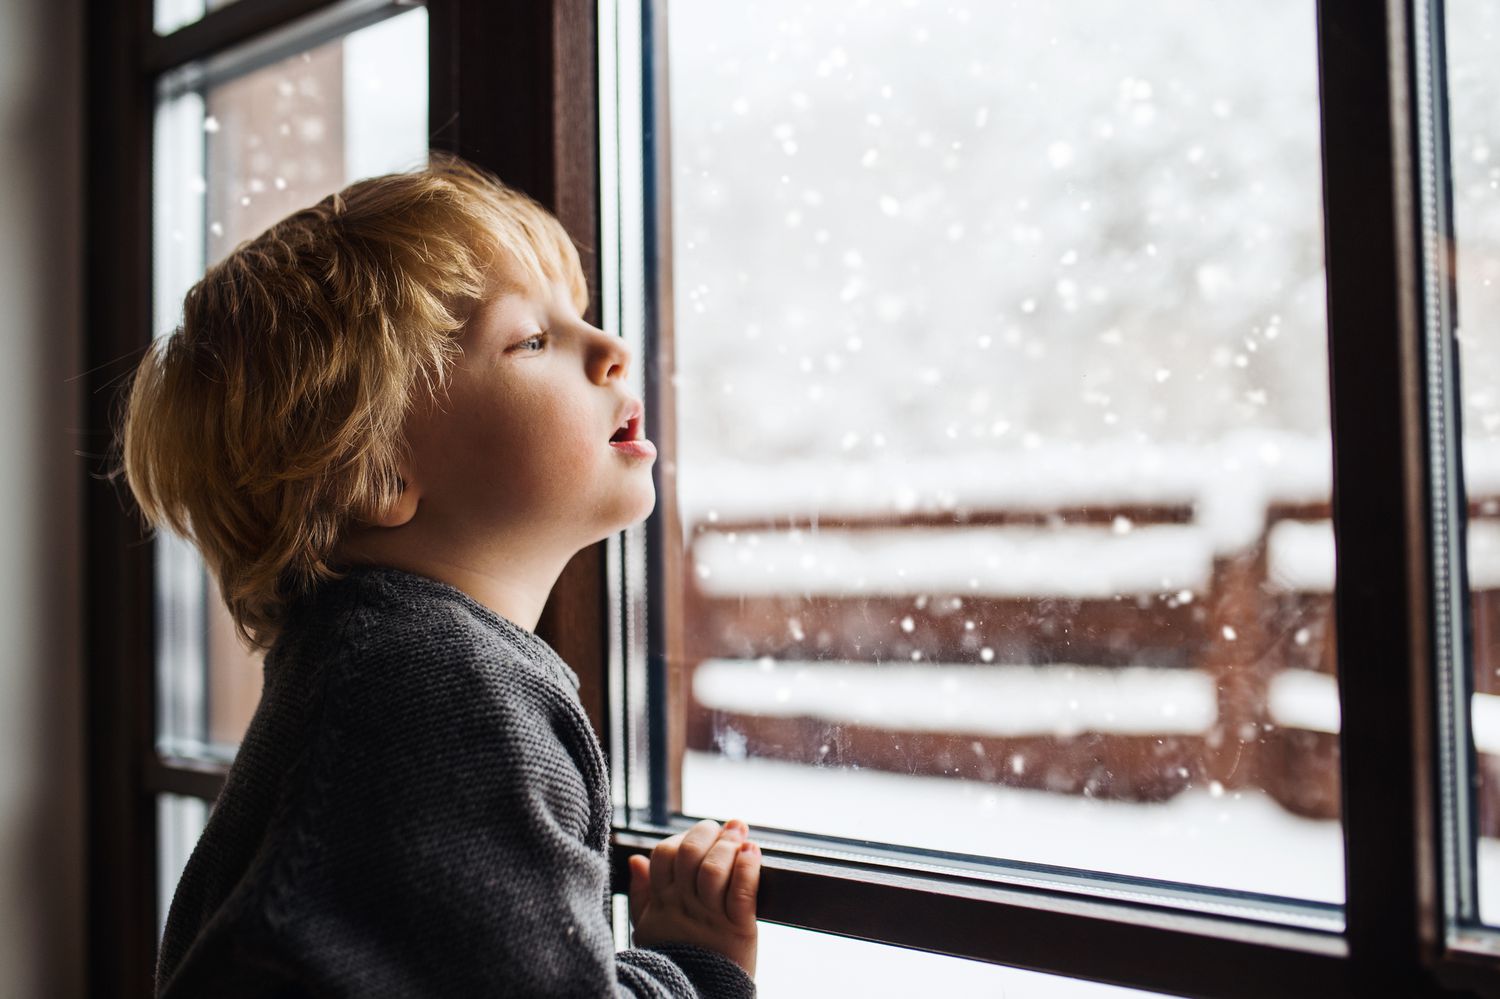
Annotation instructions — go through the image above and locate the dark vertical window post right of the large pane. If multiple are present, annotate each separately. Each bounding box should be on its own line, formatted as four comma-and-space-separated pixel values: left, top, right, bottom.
1319, 0, 1442, 995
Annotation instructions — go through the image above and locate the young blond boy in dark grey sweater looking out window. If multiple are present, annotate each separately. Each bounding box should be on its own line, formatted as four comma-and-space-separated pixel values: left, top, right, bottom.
122, 155, 761, 998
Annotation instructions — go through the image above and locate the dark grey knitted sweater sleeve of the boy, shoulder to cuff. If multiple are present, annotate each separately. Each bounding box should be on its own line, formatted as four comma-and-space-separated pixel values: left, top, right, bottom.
247, 642, 755, 999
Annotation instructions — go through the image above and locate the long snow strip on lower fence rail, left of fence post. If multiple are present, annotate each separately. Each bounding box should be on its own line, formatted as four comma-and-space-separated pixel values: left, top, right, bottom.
693, 659, 1218, 737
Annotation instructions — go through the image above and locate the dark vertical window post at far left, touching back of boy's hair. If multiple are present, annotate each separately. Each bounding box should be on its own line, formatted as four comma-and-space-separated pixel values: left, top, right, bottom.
83, 0, 156, 996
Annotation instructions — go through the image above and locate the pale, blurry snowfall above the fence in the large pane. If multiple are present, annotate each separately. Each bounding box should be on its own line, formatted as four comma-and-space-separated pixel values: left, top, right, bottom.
668, 0, 1328, 468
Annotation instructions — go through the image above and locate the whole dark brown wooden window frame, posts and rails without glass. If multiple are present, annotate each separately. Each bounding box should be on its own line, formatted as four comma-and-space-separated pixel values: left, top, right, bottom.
84, 0, 1500, 996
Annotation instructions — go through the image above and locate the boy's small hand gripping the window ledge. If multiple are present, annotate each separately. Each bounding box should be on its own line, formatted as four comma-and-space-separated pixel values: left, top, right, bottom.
630, 819, 761, 978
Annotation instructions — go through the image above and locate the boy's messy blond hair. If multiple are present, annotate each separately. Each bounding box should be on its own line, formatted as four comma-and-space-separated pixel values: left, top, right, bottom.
119, 152, 588, 648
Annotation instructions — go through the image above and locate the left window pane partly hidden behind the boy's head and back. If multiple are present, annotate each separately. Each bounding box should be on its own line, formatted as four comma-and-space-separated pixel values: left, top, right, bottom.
153, 8, 428, 758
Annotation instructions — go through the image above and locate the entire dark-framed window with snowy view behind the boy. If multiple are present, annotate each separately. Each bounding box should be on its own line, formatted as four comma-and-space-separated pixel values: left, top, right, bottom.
87, 0, 1500, 996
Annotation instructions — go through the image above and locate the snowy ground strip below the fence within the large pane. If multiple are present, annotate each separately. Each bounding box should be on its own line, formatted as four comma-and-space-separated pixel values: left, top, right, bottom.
683, 752, 1344, 903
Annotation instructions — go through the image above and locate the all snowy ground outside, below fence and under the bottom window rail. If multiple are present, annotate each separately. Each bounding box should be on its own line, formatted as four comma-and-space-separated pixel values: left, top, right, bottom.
683, 752, 1500, 999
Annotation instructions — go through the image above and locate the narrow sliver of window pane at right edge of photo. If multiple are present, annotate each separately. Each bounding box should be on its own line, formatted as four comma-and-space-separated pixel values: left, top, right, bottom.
1443, 0, 1500, 924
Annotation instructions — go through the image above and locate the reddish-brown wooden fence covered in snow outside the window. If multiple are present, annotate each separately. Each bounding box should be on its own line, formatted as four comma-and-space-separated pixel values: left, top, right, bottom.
678, 432, 1500, 834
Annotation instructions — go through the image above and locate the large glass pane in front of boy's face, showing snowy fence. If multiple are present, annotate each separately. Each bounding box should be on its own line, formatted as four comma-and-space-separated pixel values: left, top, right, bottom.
657, 0, 1343, 902
